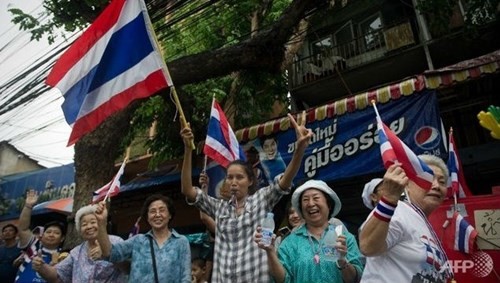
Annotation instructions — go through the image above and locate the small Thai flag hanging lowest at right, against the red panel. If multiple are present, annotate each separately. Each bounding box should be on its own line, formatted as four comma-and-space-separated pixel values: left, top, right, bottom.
451, 211, 477, 254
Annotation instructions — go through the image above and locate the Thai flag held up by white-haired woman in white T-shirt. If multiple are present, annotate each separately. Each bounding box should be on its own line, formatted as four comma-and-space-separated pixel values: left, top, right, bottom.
373, 103, 434, 190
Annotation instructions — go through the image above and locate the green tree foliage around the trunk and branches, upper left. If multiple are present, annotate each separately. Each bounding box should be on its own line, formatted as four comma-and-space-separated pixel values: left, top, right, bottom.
7, 0, 291, 166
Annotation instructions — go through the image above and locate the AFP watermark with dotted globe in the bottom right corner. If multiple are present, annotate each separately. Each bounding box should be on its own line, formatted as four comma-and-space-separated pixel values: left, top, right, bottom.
448, 252, 493, 278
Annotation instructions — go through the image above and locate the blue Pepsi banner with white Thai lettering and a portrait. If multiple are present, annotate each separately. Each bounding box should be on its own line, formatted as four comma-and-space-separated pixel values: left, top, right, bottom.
244, 91, 446, 185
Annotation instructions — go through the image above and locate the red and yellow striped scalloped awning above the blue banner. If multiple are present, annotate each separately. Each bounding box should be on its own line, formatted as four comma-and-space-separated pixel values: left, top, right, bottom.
235, 50, 500, 142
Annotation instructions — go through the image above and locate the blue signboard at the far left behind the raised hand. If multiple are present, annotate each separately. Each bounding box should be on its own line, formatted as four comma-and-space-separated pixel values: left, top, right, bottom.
0, 163, 75, 221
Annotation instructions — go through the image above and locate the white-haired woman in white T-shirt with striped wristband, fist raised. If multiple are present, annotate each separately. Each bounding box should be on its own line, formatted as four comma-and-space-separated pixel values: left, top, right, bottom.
360, 155, 452, 283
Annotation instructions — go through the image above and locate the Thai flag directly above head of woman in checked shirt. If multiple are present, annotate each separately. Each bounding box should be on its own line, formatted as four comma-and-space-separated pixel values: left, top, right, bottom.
203, 99, 246, 168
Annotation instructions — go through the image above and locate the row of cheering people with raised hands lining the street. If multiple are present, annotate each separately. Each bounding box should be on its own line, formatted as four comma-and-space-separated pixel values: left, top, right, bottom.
0, 115, 453, 283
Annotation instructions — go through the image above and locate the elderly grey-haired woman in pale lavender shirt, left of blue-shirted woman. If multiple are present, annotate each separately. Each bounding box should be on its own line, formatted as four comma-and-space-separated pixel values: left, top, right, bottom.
33, 205, 127, 283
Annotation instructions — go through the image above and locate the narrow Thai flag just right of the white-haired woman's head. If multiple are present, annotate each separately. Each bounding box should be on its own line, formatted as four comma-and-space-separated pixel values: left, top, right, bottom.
447, 130, 471, 198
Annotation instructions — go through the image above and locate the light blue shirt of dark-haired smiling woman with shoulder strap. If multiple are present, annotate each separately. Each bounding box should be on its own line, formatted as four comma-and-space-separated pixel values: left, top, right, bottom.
109, 230, 191, 283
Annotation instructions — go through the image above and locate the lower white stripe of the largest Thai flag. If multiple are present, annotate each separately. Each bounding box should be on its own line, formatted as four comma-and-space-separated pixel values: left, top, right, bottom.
77, 52, 159, 120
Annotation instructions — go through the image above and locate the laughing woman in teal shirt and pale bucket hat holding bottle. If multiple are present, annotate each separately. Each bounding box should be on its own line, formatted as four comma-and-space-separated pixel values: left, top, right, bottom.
255, 180, 363, 282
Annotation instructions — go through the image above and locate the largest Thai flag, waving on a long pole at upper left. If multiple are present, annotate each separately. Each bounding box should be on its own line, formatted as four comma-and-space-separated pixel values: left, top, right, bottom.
46, 0, 172, 145
